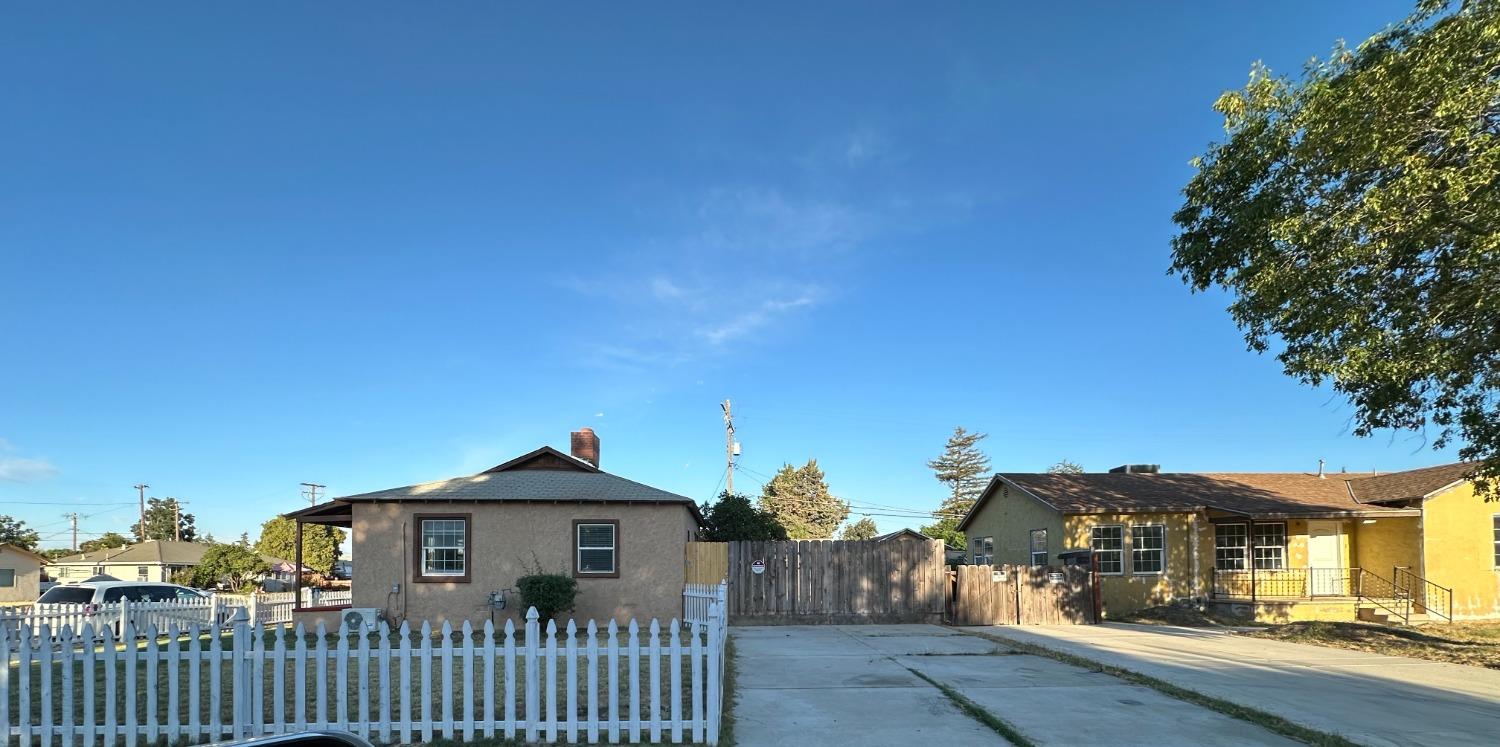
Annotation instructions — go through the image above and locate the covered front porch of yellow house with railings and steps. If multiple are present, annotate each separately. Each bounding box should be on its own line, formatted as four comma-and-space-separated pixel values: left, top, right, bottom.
1209, 509, 1452, 623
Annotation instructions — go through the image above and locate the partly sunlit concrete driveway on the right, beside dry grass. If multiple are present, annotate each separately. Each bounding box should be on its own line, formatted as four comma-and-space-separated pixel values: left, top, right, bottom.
971, 623, 1500, 747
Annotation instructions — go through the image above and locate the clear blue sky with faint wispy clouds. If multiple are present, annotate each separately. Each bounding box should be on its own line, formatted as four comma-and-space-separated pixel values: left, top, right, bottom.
0, 0, 1454, 546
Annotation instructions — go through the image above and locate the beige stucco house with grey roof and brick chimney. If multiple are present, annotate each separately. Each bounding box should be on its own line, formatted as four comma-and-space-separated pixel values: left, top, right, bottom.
288, 428, 702, 624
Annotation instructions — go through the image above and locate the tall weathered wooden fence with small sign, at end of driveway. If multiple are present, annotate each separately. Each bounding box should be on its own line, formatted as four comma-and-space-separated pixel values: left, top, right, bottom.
726, 540, 947, 624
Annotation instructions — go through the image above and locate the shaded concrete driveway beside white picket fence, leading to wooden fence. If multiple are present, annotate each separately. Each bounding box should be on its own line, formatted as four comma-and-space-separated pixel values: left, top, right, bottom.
731, 626, 1296, 747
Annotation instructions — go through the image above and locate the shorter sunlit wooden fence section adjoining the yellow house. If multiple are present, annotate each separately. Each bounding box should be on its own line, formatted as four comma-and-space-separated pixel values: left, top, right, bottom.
948, 566, 1098, 626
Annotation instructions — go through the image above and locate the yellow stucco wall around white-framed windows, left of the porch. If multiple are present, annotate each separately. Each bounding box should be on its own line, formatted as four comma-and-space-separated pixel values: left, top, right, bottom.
1065, 513, 1214, 617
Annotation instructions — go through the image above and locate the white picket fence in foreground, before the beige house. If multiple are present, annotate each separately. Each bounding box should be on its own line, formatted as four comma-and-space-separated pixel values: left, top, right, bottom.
0, 609, 726, 747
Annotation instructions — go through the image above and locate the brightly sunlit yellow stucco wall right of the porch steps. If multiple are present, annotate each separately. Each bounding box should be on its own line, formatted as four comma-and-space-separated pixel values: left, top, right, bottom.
1421, 483, 1500, 618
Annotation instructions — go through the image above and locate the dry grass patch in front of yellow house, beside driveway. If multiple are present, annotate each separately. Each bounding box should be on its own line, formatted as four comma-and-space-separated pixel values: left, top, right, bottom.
1241, 621, 1500, 669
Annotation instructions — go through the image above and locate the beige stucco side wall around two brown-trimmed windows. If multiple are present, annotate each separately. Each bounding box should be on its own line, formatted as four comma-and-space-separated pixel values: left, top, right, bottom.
353, 503, 696, 626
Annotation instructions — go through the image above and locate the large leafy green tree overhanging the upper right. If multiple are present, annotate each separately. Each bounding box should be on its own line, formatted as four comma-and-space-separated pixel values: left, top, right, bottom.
1172, 0, 1500, 485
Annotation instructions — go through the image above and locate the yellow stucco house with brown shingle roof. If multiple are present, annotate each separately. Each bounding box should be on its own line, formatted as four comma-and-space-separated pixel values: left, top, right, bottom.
959, 464, 1500, 623
